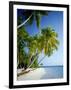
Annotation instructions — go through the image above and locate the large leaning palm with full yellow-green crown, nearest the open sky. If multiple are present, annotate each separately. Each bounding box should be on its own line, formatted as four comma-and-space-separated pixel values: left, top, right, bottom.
38, 27, 59, 64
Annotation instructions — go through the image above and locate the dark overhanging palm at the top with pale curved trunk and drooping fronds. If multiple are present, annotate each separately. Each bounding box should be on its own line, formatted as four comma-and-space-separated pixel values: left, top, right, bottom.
17, 10, 48, 29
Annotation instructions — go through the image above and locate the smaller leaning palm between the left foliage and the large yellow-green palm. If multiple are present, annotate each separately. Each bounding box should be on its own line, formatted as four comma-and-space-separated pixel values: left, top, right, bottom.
28, 35, 38, 68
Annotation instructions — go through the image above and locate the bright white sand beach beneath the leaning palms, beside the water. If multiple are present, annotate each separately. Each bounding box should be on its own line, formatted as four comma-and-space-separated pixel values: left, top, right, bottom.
17, 68, 46, 81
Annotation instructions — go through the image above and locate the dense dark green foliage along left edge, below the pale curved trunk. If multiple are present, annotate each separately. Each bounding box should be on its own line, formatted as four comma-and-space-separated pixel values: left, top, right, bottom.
17, 27, 28, 68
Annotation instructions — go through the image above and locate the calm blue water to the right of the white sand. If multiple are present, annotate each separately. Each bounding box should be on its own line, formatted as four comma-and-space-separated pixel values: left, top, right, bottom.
41, 66, 63, 79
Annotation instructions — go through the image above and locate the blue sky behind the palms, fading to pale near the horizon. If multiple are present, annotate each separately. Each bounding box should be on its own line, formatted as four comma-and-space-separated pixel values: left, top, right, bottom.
17, 11, 63, 66
